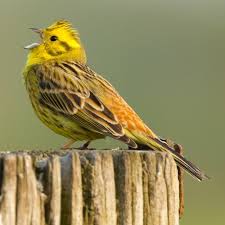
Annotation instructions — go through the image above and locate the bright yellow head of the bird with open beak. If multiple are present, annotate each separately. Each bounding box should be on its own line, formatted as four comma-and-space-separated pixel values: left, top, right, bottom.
25, 20, 86, 66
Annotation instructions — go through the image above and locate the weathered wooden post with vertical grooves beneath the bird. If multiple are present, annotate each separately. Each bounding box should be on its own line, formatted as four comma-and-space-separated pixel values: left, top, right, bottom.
0, 150, 179, 225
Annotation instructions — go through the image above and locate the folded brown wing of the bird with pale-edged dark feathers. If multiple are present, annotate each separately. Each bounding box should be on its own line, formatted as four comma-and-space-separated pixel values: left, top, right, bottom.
36, 62, 137, 148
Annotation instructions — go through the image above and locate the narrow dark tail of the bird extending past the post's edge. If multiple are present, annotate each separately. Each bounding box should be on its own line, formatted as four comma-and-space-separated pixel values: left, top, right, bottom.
144, 135, 209, 181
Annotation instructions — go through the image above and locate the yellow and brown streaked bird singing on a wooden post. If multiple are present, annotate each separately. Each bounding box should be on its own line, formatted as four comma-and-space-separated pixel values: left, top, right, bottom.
23, 20, 208, 181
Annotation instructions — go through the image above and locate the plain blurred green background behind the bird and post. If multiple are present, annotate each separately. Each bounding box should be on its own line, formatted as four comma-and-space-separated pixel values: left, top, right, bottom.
0, 0, 225, 225
